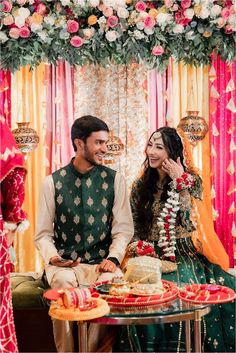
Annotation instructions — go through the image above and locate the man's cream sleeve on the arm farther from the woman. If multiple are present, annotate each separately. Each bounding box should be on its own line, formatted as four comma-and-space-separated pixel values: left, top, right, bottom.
35, 175, 58, 265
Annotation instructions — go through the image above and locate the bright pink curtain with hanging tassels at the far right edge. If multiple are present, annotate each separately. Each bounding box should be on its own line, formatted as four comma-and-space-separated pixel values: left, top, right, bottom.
209, 58, 236, 267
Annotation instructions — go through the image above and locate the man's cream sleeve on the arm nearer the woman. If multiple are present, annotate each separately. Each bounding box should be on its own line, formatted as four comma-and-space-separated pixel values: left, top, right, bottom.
108, 173, 134, 263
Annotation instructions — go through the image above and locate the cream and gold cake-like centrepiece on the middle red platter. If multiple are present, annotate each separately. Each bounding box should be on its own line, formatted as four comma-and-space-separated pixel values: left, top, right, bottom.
124, 256, 162, 288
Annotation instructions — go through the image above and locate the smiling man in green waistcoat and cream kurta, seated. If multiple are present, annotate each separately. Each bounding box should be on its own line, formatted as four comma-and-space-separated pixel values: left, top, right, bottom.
35, 116, 133, 352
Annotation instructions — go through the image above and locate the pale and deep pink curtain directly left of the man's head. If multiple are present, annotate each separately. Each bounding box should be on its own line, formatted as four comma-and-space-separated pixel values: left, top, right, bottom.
46, 62, 74, 174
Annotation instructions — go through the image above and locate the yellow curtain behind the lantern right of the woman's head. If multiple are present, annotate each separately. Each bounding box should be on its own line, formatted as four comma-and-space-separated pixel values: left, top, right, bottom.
167, 62, 212, 210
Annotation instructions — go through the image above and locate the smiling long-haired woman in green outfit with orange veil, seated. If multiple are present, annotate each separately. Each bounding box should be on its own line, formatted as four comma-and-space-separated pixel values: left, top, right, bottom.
116, 127, 235, 352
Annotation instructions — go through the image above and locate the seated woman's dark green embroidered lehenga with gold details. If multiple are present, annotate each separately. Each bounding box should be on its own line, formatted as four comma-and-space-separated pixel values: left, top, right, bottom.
113, 180, 235, 352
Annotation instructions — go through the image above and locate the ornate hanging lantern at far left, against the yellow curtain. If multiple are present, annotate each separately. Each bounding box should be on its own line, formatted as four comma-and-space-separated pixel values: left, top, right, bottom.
12, 122, 39, 153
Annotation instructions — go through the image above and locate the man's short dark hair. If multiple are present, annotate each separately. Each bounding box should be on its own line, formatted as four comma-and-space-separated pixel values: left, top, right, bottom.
71, 115, 109, 151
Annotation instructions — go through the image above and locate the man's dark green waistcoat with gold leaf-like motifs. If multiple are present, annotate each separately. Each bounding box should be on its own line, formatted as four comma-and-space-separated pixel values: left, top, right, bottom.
52, 162, 116, 264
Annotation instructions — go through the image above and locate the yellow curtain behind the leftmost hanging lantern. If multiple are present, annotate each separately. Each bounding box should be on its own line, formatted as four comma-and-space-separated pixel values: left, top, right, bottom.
11, 64, 46, 272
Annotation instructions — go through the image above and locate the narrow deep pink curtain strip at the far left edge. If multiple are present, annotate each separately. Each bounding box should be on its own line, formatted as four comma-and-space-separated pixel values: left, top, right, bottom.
0, 70, 11, 127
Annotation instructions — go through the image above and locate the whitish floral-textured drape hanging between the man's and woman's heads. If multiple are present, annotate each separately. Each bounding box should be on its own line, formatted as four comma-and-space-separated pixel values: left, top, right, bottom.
75, 64, 149, 186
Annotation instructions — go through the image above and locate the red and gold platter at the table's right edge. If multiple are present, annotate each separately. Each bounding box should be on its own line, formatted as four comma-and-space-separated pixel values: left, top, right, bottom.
179, 284, 236, 304
